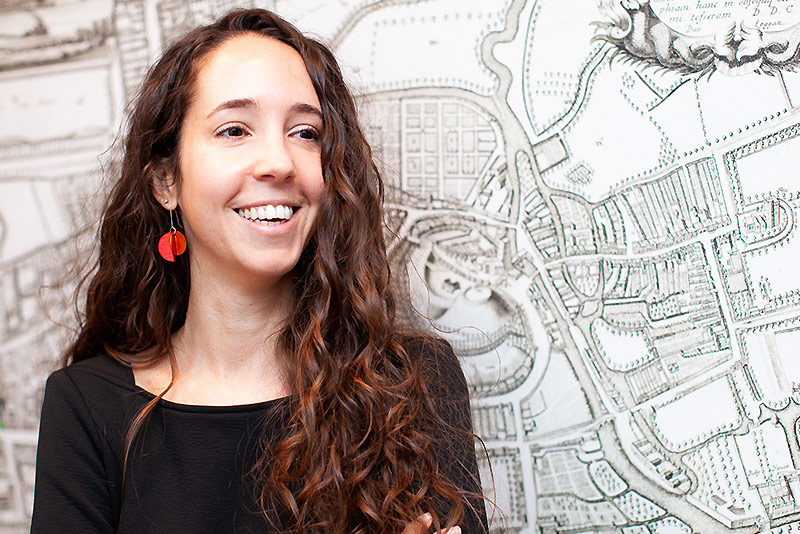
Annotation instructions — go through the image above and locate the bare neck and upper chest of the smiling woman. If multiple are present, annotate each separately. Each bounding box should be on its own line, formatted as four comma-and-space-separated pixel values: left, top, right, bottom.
134, 279, 294, 405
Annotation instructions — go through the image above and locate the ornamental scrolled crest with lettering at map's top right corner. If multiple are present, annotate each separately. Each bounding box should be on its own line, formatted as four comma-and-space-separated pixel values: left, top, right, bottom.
595, 0, 800, 76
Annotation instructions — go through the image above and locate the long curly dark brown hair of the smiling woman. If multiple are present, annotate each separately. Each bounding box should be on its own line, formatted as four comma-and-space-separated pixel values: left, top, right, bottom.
65, 9, 484, 533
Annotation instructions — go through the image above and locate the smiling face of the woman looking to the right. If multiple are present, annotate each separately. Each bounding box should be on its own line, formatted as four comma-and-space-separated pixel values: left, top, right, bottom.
173, 34, 324, 289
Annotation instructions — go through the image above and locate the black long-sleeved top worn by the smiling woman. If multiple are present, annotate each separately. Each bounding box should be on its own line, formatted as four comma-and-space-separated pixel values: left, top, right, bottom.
31, 347, 486, 534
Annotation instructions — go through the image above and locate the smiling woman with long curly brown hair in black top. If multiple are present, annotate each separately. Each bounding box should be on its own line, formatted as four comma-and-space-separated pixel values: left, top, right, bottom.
32, 10, 486, 534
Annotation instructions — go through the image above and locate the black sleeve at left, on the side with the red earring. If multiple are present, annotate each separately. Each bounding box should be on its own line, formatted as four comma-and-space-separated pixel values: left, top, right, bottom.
31, 369, 116, 534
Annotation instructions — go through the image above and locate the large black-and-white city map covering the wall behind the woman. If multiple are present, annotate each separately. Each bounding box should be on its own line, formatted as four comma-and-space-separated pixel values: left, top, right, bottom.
0, 0, 800, 534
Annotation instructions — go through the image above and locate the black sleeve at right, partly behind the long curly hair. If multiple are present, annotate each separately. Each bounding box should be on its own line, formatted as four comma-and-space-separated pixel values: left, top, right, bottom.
423, 340, 488, 534
